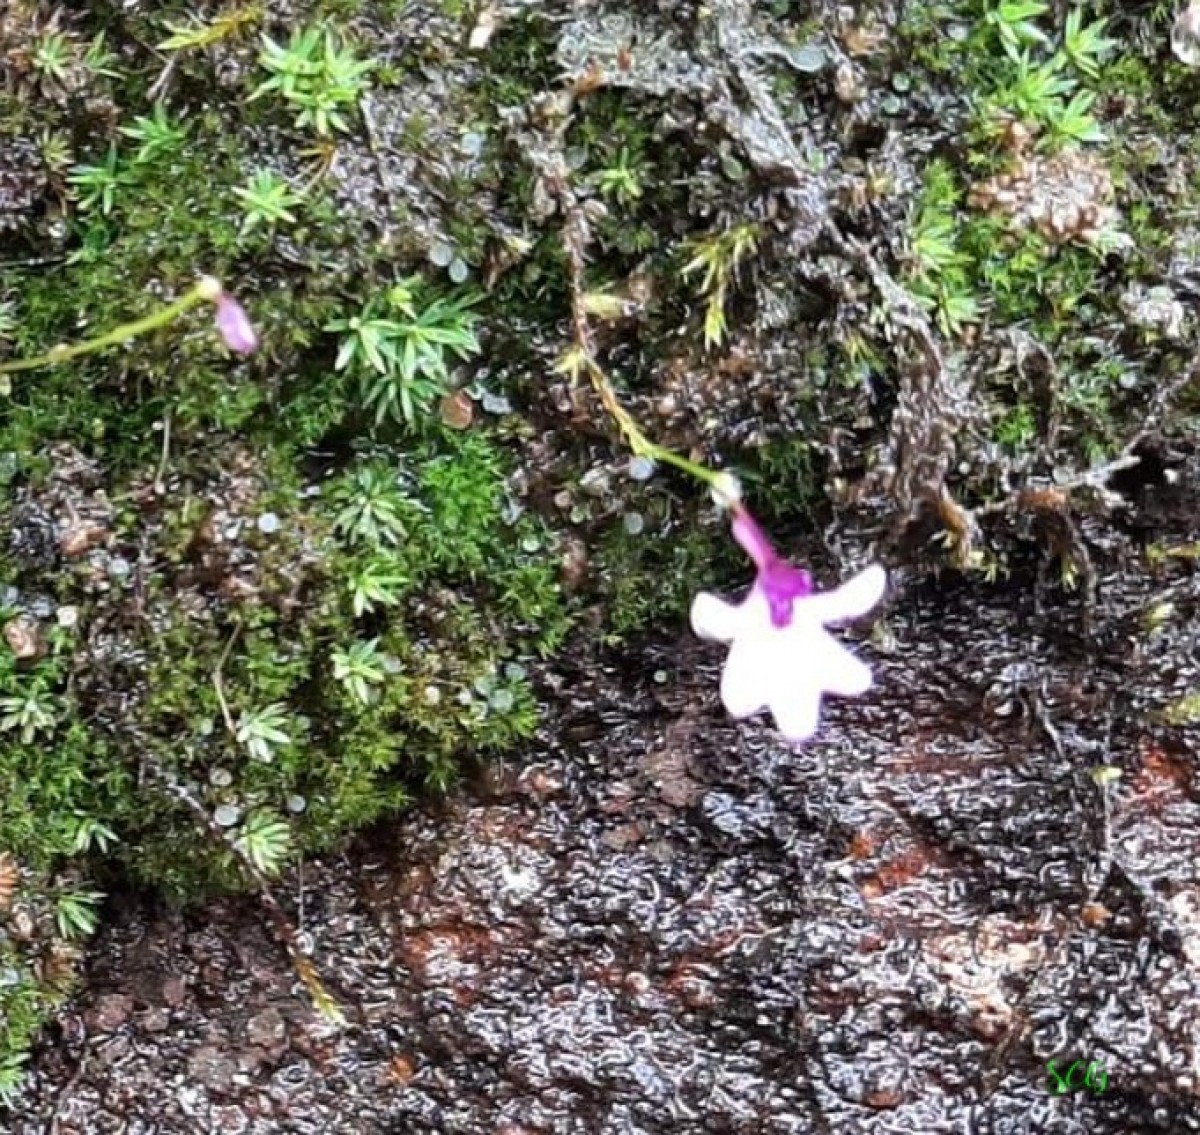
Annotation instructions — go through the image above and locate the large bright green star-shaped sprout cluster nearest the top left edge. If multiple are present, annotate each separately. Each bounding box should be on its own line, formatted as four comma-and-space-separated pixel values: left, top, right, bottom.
250, 25, 374, 134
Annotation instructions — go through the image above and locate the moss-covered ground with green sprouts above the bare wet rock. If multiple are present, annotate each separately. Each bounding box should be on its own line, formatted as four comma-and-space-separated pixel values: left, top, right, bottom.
0, 0, 1200, 1095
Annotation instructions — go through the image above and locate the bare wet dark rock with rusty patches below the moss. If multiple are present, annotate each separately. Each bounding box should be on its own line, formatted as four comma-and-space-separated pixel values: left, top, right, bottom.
10, 463, 1200, 1135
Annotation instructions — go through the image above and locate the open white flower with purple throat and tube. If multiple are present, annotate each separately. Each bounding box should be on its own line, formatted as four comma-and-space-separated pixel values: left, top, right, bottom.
691, 502, 887, 741
